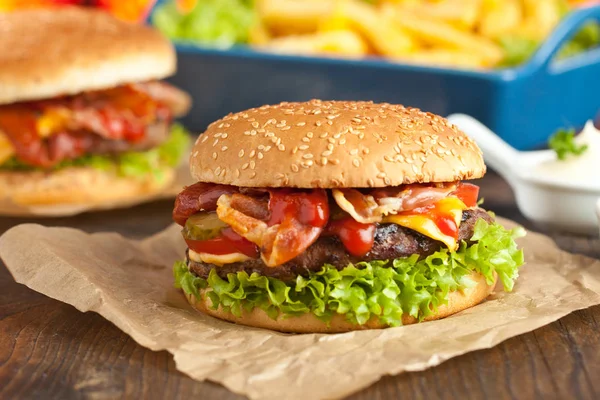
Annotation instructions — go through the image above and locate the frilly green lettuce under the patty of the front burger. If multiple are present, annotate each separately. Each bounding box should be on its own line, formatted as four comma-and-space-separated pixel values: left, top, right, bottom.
173, 219, 525, 326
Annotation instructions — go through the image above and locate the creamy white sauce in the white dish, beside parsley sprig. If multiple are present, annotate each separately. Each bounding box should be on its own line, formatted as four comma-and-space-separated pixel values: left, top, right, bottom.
535, 121, 600, 184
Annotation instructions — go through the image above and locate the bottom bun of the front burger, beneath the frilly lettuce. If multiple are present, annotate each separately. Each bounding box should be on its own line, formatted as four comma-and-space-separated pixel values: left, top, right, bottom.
186, 272, 498, 333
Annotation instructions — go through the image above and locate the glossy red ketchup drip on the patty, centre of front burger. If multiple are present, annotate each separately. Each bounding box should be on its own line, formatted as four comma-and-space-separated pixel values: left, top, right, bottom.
327, 216, 375, 257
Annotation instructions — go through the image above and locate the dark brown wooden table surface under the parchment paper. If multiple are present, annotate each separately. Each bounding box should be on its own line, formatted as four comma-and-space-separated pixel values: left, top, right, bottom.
0, 173, 600, 400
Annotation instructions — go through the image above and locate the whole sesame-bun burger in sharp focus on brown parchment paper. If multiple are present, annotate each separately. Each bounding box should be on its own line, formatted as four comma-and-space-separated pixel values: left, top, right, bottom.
173, 100, 523, 333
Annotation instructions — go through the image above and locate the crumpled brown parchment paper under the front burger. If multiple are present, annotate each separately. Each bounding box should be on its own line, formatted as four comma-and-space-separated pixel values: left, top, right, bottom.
0, 221, 600, 400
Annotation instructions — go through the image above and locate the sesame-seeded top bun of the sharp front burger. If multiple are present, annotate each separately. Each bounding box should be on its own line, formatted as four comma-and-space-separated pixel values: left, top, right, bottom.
190, 100, 485, 188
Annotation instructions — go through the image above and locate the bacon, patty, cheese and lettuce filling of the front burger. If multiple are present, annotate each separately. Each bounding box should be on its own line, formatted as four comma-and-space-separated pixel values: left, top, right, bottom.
173, 182, 523, 325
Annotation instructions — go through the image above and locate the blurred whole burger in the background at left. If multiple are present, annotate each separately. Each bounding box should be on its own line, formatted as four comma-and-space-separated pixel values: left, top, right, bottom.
0, 7, 190, 205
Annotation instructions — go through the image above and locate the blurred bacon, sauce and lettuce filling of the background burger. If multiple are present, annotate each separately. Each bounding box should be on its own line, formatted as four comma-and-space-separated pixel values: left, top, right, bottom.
0, 82, 189, 179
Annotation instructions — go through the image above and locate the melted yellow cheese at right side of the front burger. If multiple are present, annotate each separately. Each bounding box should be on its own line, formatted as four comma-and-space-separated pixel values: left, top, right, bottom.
383, 197, 468, 251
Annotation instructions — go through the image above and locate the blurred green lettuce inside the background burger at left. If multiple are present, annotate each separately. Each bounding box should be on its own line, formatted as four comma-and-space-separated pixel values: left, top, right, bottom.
0, 124, 190, 180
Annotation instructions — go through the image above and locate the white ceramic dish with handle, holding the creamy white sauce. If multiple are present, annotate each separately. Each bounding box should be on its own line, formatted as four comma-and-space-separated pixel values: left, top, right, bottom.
448, 114, 600, 235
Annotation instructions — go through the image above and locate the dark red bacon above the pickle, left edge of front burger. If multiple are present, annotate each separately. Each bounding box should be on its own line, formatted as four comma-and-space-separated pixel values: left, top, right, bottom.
173, 182, 238, 226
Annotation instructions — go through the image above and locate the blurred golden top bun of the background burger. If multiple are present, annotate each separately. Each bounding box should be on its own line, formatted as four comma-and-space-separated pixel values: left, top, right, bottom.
0, 7, 175, 104
